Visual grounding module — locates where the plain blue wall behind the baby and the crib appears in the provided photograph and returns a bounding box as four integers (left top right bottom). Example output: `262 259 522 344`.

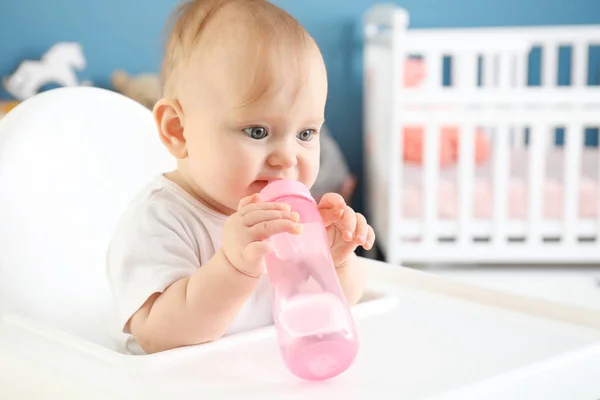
0 0 600 212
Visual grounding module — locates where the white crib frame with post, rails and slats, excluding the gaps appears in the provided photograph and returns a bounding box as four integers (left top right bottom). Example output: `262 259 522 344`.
364 4 600 264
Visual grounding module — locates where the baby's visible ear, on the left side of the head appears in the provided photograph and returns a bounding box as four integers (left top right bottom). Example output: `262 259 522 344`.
153 98 188 159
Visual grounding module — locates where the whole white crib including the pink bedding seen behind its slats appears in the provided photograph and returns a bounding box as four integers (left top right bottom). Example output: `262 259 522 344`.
364 5 600 264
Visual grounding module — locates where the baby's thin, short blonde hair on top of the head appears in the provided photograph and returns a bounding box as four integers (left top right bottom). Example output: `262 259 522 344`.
161 0 314 104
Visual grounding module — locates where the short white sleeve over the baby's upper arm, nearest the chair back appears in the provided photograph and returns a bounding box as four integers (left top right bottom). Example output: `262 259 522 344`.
107 203 200 333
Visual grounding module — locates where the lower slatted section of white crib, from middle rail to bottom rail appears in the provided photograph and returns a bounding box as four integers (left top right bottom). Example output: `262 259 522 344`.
396 110 600 262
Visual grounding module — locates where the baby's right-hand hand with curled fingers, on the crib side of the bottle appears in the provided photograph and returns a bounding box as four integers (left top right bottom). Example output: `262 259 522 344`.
319 193 375 268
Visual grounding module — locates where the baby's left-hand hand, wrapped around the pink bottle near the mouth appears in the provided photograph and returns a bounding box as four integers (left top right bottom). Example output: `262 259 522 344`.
223 194 302 278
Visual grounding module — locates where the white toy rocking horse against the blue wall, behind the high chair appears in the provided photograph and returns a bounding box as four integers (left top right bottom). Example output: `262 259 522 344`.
2 42 91 101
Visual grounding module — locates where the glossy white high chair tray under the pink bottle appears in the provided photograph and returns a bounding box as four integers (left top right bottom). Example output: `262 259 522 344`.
0 259 600 400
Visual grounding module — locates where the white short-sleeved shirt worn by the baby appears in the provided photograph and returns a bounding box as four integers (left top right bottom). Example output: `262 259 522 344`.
107 175 273 354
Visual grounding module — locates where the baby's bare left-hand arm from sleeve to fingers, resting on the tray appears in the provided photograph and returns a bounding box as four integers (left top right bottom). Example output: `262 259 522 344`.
123 196 300 353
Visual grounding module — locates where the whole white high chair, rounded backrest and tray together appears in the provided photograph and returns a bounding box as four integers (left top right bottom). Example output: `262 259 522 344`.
0 87 600 400
